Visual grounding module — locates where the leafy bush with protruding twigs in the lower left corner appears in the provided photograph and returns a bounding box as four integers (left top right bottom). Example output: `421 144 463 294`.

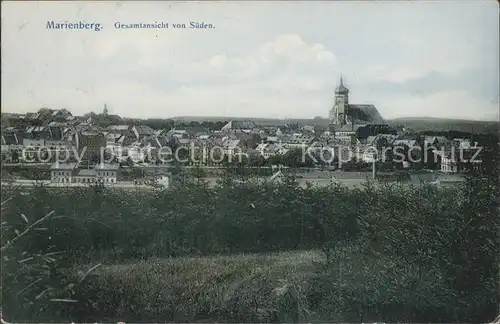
0 188 100 323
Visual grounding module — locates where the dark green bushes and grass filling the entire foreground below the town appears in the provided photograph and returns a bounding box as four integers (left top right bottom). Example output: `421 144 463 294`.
2 162 500 322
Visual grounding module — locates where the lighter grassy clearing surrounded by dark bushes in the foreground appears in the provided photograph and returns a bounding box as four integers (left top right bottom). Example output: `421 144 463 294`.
71 251 325 322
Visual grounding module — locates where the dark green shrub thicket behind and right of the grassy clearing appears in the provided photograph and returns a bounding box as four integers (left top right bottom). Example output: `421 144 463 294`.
3 168 499 322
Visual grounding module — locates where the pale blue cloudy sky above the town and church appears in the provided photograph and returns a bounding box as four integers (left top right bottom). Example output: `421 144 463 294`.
2 0 499 120
